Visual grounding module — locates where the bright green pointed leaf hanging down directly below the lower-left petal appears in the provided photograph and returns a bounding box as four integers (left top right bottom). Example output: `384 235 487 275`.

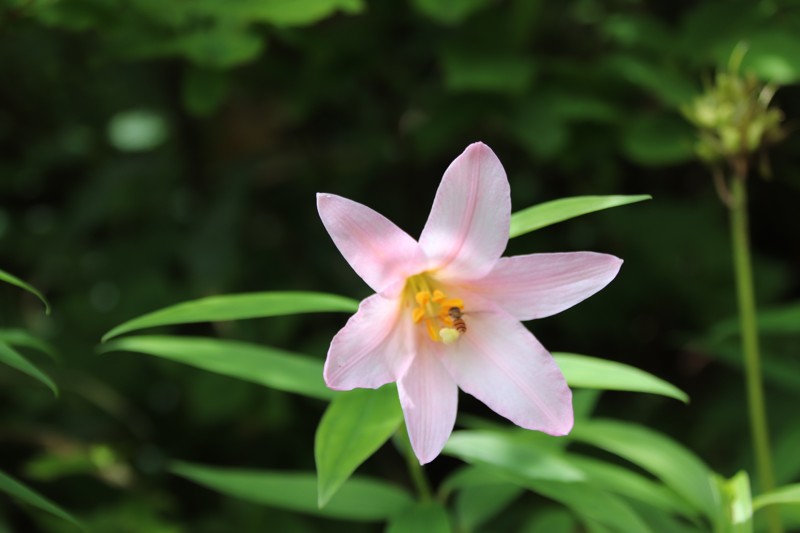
314 386 403 507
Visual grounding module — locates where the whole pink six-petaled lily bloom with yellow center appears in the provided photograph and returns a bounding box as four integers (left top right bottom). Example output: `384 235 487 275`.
317 143 622 464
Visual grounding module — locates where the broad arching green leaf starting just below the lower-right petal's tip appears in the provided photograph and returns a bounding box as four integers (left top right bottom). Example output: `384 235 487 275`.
570 419 720 518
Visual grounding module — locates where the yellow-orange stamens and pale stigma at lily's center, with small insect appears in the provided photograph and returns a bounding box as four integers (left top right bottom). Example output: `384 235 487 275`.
403 272 467 344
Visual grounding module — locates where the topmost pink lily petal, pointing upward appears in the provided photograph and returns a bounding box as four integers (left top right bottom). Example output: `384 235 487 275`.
419 143 511 279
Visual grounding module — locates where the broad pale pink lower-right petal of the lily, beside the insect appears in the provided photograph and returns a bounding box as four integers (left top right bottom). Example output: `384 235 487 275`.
442 302 573 435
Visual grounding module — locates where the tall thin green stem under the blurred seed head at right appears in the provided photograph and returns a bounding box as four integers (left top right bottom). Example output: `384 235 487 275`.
730 175 783 533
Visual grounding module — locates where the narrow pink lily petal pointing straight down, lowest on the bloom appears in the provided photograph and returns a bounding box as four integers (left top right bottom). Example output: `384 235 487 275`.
397 341 458 465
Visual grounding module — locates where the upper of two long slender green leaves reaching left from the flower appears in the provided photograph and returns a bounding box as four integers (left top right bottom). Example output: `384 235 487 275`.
103 292 358 342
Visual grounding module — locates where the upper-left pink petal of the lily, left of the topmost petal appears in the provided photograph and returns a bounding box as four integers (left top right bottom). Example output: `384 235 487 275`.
317 193 426 292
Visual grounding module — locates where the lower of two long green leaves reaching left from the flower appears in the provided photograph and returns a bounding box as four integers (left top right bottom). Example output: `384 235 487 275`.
99 335 334 400
